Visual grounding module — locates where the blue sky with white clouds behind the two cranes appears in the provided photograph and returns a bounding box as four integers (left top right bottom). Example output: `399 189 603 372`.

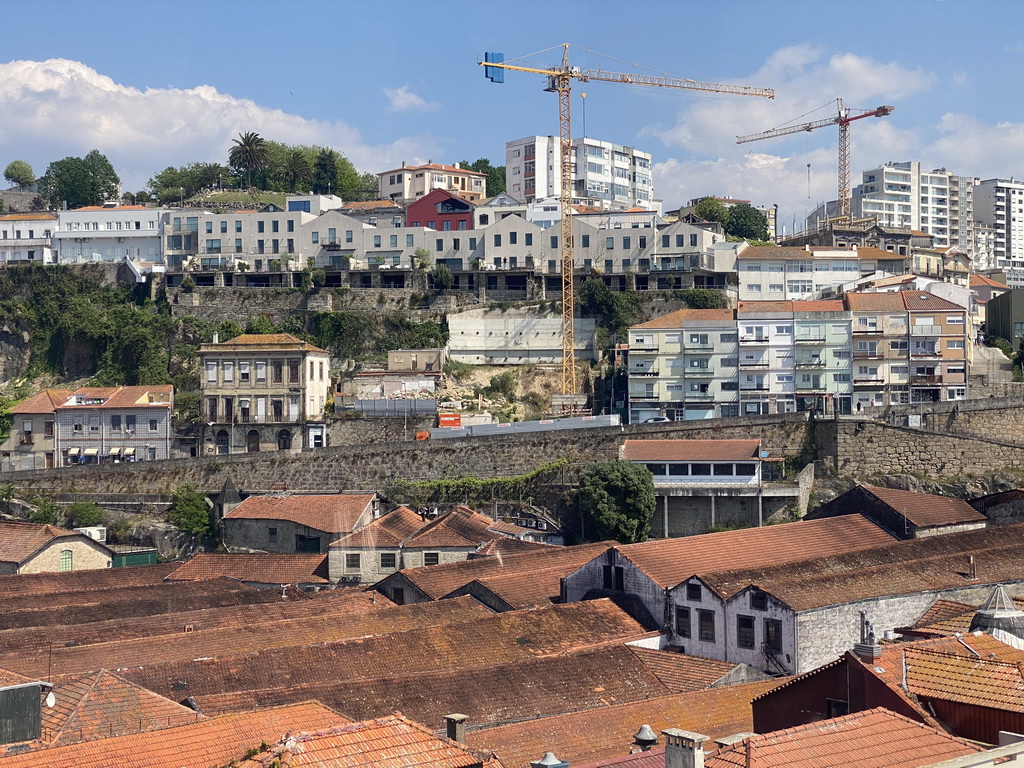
0 0 1024 230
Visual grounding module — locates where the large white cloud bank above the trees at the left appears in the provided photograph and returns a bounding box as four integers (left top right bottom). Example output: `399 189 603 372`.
0 58 438 189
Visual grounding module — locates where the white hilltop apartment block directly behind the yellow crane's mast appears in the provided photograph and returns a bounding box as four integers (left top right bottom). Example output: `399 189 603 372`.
505 136 658 210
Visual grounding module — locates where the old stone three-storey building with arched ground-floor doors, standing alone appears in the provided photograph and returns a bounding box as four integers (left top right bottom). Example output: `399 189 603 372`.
199 334 331 455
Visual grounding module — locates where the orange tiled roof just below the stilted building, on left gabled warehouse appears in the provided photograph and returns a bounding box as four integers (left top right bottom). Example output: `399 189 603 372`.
602 515 894 588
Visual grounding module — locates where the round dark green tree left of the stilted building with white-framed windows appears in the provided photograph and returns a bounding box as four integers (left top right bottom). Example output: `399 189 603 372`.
577 461 655 544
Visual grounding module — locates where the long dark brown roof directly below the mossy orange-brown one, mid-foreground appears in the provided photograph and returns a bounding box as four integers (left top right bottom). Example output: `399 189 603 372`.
198 644 675 727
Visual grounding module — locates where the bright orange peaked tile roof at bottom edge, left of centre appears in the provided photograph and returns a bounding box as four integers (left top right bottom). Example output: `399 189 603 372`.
233 713 495 768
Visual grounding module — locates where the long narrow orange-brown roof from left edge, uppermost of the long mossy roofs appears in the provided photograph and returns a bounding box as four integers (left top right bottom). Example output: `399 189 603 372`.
0 590 493 679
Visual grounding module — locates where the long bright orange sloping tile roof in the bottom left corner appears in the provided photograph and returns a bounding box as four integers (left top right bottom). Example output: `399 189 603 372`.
0 701 348 768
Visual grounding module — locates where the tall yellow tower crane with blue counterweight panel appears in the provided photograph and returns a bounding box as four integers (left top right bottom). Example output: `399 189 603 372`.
477 43 775 403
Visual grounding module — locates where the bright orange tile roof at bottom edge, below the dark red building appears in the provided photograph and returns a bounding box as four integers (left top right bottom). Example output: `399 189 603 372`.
705 707 984 768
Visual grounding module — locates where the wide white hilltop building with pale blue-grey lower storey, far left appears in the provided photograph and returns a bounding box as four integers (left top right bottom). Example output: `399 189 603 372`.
51 204 164 264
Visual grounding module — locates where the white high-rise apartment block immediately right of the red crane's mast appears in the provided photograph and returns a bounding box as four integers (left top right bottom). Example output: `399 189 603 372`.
851 162 976 253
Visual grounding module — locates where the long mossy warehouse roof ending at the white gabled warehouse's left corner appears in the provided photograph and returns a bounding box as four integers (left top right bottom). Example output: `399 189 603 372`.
117 600 642 698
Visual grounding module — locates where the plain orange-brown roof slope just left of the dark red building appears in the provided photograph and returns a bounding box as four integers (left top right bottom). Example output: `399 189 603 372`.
466 680 779 768
